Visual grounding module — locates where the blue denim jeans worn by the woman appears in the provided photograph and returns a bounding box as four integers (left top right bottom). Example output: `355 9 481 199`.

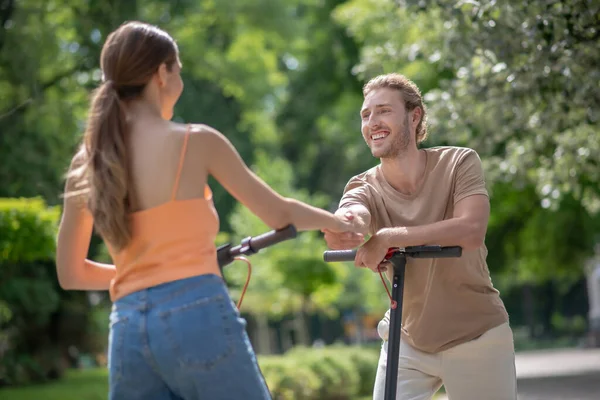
108 275 271 400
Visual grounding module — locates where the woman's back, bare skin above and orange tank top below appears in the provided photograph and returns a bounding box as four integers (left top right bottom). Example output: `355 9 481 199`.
107 119 220 301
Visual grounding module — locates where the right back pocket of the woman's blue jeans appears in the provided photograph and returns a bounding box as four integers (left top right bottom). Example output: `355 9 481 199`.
158 294 237 370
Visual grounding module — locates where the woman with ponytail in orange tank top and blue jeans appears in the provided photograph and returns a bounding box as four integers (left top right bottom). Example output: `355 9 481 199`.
56 22 352 400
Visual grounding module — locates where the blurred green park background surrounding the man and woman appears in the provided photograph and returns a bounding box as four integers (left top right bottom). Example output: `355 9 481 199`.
0 0 600 400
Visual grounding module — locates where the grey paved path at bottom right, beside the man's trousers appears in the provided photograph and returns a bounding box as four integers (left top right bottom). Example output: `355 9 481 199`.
436 349 600 400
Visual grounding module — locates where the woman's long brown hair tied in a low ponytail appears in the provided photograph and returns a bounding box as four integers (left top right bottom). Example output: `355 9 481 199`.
67 22 177 251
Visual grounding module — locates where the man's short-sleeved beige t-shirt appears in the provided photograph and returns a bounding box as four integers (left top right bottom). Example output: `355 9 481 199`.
340 147 508 353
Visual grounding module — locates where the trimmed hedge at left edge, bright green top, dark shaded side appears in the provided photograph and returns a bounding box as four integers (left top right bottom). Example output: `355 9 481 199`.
0 198 100 384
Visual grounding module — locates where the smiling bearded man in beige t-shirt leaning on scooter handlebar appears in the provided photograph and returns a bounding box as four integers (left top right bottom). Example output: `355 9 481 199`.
325 74 517 400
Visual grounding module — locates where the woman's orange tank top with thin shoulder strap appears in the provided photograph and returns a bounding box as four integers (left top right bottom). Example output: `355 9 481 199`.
107 130 221 302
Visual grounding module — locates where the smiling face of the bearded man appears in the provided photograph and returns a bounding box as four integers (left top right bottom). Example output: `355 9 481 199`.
360 88 412 158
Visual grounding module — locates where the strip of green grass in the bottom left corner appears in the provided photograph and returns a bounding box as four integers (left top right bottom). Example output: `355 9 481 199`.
0 368 108 400
